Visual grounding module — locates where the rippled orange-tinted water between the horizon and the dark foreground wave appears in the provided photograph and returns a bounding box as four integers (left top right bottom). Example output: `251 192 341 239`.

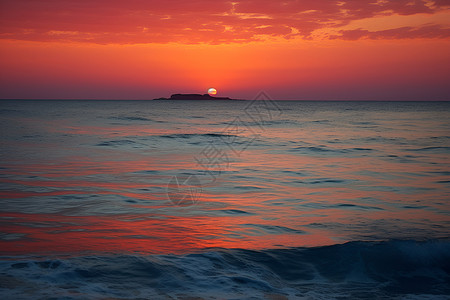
0 101 450 254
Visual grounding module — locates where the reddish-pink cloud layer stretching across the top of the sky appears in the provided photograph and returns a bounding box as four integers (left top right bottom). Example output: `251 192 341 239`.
0 0 450 44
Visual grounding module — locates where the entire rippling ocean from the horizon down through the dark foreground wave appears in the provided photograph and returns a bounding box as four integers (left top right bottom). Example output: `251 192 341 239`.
0 99 450 299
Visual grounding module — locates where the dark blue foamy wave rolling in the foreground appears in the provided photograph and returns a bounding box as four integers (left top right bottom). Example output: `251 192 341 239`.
0 240 450 299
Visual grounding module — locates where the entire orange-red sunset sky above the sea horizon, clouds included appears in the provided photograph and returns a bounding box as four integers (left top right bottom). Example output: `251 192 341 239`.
0 0 450 100
